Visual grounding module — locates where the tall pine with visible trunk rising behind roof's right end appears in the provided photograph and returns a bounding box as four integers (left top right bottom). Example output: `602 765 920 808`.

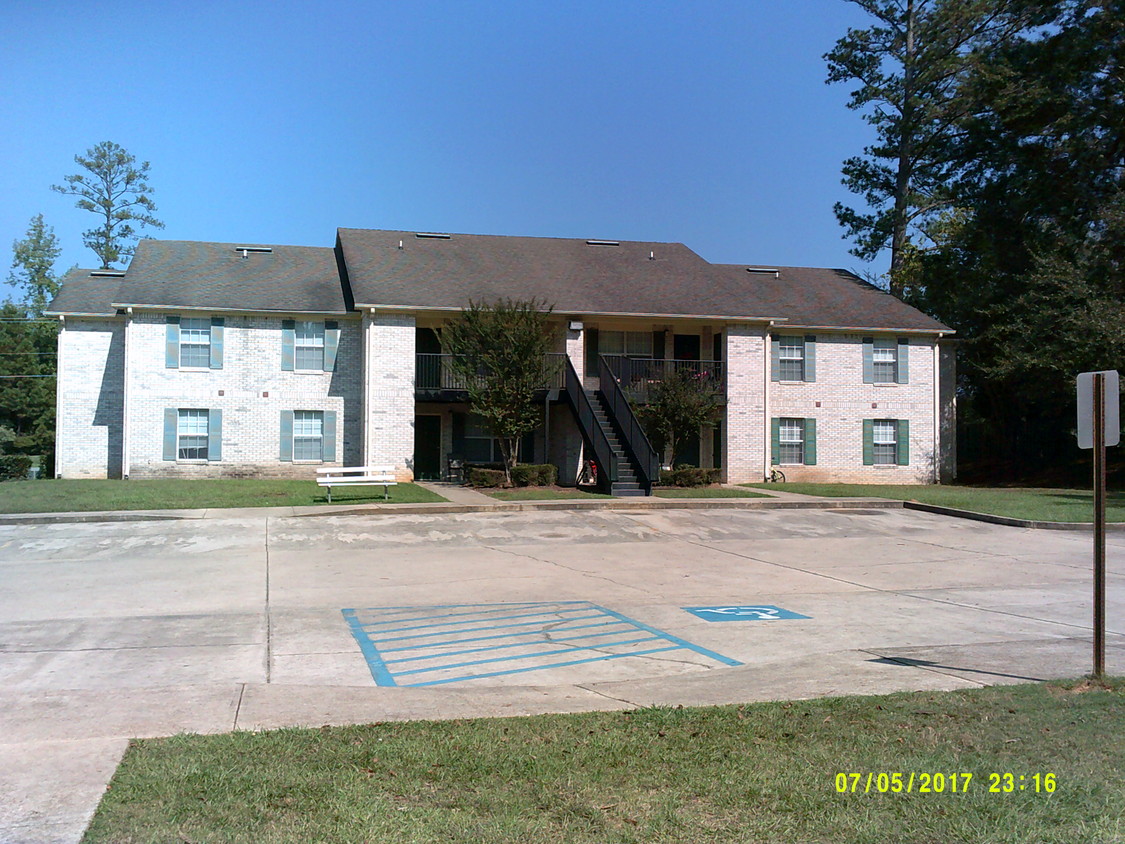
825 0 1055 296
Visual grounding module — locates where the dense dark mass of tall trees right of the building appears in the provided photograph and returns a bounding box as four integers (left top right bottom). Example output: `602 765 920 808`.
825 0 1125 481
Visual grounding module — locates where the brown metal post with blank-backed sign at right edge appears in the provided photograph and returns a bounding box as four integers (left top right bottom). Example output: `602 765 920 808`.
1078 370 1121 677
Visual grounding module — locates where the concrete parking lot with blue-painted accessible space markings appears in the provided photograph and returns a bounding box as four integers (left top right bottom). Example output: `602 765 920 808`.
0 508 1125 841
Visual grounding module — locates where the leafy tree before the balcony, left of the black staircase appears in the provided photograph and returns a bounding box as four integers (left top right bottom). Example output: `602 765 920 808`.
441 299 551 484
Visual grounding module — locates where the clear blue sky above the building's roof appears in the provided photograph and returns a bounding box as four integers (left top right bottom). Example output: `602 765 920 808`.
0 0 883 294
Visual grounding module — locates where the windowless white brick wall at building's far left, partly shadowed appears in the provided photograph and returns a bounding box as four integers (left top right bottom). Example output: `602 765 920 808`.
55 317 125 478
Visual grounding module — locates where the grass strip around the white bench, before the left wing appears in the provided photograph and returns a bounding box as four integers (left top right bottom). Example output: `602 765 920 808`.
0 478 444 513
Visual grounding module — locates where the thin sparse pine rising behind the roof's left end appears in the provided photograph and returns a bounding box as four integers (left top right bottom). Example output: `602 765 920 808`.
51 141 164 269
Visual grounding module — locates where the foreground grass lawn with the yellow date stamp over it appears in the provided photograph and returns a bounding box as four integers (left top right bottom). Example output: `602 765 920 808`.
84 680 1125 844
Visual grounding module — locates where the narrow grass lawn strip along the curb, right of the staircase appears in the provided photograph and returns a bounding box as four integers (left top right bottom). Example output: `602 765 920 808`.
744 484 1125 522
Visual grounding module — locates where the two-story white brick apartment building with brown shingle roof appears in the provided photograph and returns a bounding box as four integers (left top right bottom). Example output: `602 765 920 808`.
47 228 954 493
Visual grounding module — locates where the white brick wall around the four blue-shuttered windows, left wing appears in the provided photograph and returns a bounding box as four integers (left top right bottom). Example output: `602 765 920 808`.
127 313 362 477
